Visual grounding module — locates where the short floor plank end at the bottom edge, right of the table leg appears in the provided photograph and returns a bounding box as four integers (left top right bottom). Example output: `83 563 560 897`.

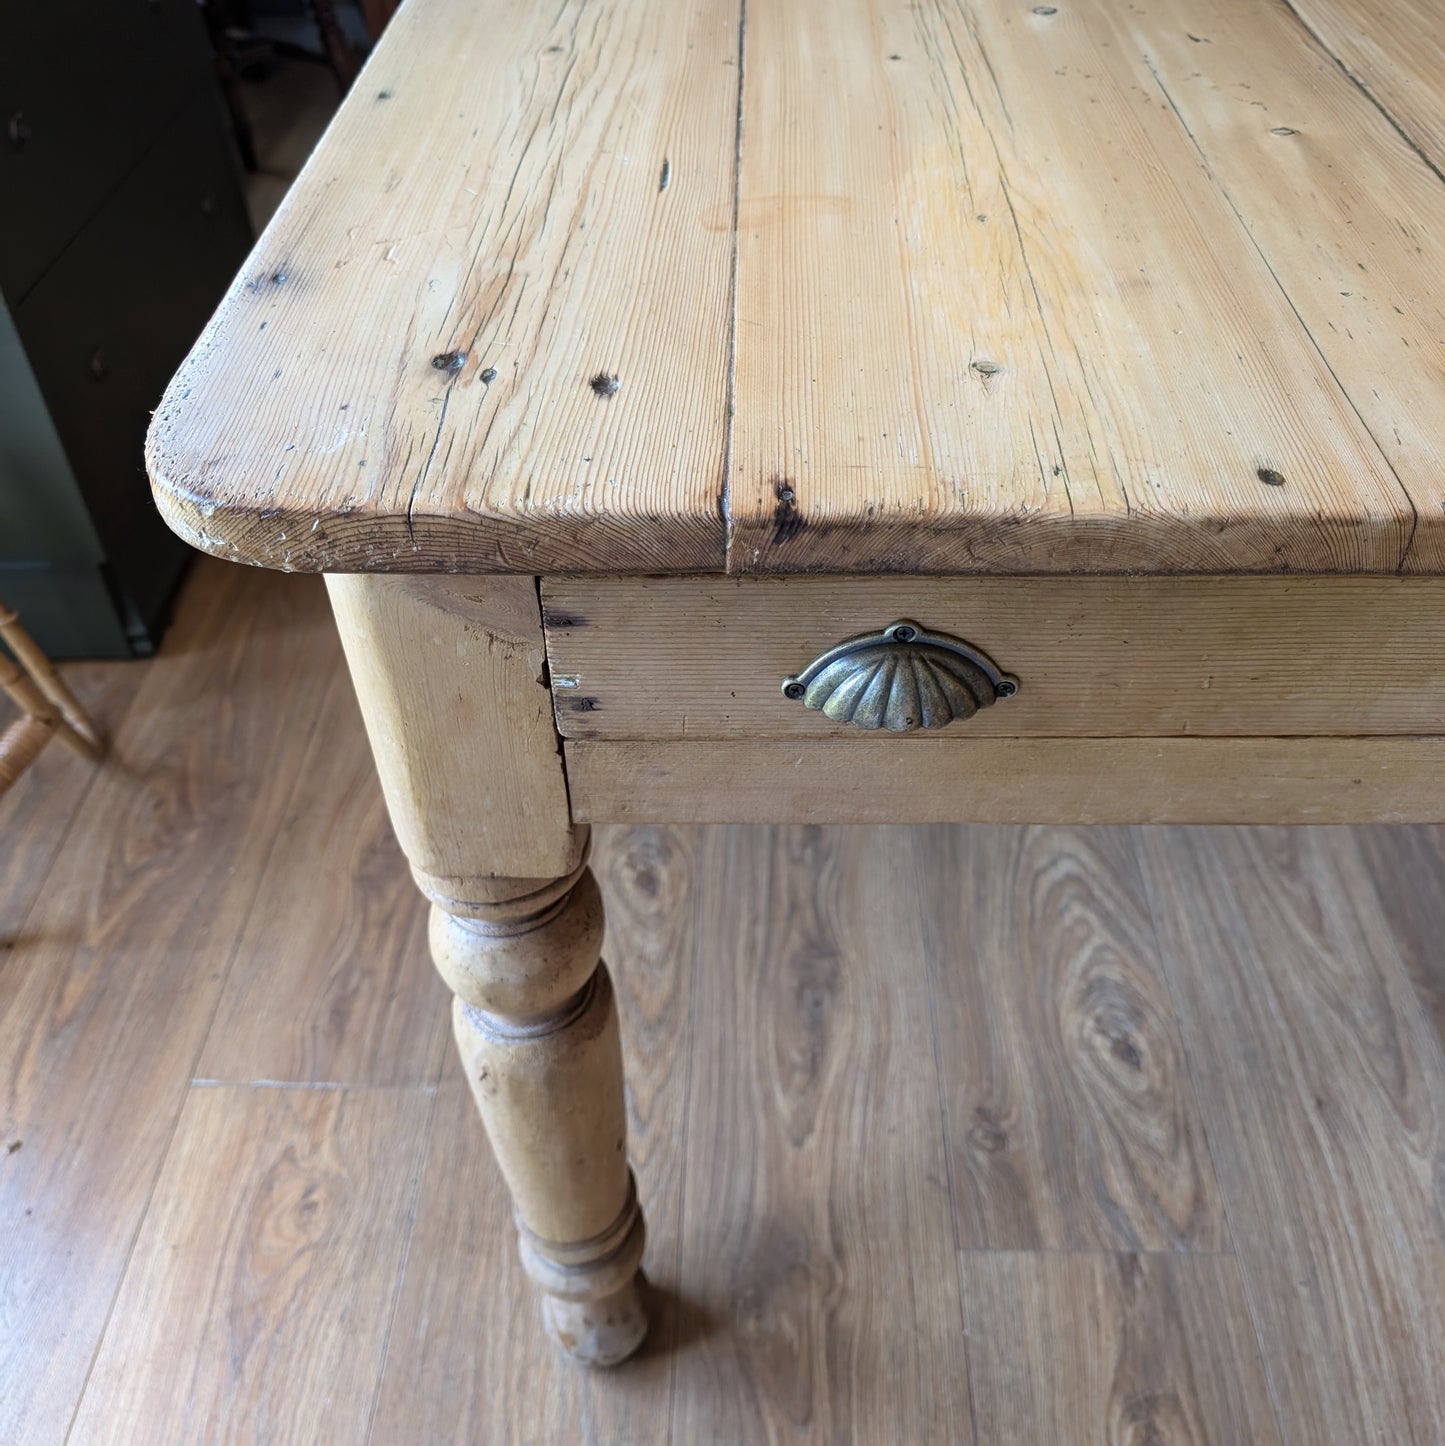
963 1255 1284 1446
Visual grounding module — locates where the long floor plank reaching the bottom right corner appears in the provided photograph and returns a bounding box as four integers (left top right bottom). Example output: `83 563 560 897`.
1141 829 1445 1446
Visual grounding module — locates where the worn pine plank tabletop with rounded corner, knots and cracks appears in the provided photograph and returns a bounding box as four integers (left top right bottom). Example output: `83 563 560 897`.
149 0 1445 573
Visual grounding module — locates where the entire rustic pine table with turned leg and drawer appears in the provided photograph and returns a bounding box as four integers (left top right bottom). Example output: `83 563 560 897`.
148 0 1445 1365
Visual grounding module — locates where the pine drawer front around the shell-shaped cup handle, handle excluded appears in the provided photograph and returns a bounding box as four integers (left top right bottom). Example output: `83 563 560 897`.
542 577 1445 746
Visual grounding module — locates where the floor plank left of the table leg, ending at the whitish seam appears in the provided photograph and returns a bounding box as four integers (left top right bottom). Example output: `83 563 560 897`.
197 665 450 1086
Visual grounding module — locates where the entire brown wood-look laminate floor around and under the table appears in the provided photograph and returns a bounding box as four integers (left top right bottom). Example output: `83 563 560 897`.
0 562 1445 1446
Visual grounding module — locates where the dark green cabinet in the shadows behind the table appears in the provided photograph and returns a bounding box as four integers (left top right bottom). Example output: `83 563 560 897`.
0 0 250 656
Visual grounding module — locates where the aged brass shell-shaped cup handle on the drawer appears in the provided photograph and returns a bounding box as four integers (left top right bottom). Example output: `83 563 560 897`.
783 622 1018 733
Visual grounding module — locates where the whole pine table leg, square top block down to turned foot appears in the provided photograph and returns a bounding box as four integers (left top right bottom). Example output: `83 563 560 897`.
327 577 647 1365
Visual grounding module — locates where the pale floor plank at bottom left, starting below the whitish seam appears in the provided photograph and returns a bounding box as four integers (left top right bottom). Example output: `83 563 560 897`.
69 1087 432 1446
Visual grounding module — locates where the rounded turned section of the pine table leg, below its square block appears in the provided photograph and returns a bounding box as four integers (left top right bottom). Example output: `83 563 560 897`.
431 868 647 1365
